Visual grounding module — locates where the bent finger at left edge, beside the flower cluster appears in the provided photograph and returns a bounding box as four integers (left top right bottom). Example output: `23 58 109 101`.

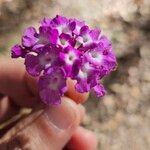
0 58 37 106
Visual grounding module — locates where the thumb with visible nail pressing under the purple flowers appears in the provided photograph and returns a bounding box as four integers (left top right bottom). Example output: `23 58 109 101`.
0 98 80 150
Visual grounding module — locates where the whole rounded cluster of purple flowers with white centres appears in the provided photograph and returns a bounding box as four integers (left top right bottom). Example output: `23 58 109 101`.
11 15 116 104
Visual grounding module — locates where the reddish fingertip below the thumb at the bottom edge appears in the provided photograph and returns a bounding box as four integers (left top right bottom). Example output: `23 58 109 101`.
64 127 97 150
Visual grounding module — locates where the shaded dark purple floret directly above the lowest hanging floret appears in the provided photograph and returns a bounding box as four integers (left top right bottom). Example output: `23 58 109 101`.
25 46 60 76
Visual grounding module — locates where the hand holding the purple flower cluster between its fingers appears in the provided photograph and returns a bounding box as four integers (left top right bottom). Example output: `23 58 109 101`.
0 58 97 150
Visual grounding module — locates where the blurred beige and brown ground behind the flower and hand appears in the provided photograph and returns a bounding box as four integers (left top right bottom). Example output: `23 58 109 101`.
0 0 150 150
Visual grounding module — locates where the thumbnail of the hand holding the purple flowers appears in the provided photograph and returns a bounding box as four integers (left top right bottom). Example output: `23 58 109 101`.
45 98 77 130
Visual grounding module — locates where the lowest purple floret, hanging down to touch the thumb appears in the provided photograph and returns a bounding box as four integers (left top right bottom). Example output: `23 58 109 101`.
38 68 67 105
